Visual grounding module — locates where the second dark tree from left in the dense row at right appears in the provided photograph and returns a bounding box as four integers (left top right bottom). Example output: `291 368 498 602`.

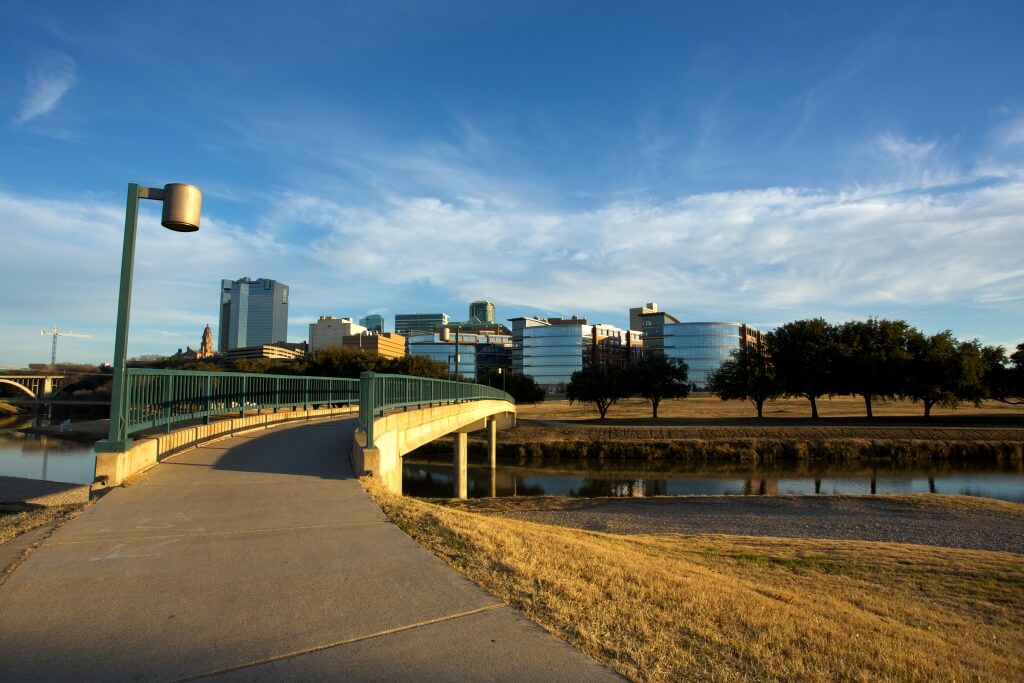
765 317 836 420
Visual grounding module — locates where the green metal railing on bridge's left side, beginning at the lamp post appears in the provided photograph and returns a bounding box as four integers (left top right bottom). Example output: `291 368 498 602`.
121 368 359 434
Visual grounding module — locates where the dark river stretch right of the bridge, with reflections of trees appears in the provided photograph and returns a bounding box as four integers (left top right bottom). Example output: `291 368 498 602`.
402 456 1024 503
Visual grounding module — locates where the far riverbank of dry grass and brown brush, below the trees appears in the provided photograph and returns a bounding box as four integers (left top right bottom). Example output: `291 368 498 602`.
420 397 1024 466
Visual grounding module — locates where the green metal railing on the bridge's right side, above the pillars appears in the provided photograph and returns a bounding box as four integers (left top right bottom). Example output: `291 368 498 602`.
359 373 515 449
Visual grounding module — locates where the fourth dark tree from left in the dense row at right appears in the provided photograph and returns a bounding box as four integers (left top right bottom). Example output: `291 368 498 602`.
906 330 986 418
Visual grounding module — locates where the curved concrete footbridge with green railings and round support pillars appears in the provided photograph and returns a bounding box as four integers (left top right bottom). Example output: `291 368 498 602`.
96 368 516 498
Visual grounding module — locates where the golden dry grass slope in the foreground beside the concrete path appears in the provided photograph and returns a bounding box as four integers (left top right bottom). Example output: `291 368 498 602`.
372 490 1024 681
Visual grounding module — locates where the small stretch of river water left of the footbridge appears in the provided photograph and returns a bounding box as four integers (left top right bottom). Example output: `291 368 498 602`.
0 419 96 483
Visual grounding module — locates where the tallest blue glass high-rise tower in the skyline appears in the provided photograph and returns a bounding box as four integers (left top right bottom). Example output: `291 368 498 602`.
217 278 288 353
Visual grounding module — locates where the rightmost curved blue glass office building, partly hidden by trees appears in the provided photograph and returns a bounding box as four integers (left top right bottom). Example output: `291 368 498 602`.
641 312 761 391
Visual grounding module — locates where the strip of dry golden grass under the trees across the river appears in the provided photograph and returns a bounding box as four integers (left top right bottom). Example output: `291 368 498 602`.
518 396 1024 424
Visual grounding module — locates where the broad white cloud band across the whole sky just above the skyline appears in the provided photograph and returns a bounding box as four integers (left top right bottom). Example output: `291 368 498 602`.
0 147 1024 362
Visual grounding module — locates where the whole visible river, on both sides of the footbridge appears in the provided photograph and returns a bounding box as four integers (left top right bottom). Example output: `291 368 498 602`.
0 418 1024 503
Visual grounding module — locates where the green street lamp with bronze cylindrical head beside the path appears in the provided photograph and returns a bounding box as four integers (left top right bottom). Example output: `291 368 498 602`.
96 182 203 453
